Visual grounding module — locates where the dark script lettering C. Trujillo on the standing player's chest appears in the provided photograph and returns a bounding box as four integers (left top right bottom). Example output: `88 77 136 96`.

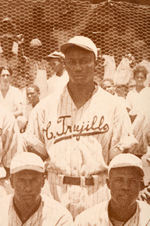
43 115 109 143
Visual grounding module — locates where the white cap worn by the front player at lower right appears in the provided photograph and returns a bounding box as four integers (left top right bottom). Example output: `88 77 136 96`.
108 153 144 176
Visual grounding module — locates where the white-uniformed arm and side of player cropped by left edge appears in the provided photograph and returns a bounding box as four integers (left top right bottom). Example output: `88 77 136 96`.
0 105 19 196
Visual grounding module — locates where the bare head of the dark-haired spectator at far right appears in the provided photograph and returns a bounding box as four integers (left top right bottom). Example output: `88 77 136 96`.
133 65 148 86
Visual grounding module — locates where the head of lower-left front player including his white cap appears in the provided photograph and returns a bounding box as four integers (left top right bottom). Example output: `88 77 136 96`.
10 152 44 206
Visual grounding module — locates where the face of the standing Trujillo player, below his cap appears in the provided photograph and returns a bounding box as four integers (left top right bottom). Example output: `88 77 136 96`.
65 47 95 85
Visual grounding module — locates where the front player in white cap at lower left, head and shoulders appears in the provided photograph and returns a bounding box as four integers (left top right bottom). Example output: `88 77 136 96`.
0 152 72 226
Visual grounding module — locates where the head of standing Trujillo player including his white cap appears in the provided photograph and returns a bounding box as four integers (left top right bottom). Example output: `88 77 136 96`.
61 36 97 85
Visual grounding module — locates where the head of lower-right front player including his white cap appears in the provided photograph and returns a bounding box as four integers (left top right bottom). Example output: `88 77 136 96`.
107 154 144 209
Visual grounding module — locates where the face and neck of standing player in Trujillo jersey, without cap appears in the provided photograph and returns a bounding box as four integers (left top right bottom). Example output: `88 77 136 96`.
65 47 96 108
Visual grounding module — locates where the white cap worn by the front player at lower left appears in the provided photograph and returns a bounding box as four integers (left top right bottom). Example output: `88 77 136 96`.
10 152 45 174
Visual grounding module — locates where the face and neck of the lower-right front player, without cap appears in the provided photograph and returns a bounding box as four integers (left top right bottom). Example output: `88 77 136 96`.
107 167 144 222
